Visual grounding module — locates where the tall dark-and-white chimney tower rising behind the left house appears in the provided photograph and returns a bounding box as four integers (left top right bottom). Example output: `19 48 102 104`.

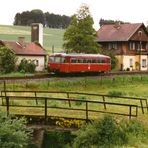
31 23 43 46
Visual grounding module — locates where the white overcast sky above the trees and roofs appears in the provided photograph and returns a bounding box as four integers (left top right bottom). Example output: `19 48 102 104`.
0 0 148 30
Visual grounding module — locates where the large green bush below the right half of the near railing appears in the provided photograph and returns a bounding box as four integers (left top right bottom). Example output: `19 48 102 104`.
74 116 127 148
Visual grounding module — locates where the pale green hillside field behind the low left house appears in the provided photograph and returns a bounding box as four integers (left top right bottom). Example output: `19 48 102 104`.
0 25 65 53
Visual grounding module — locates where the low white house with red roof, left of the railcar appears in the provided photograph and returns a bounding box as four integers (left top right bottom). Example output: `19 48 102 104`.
0 37 46 71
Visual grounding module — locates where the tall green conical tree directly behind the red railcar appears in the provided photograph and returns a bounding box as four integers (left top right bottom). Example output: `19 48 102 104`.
63 4 99 53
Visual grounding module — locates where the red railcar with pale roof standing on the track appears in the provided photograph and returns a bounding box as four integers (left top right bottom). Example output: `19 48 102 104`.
48 53 111 73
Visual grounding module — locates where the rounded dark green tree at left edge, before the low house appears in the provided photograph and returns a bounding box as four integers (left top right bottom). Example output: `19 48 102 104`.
0 46 17 73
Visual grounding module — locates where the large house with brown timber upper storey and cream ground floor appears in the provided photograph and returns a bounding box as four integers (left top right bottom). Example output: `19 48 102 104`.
97 23 148 71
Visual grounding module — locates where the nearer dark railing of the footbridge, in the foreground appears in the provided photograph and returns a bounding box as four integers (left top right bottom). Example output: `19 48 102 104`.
0 96 138 124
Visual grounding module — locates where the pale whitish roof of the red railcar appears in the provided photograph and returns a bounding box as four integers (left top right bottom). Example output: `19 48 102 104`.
50 53 110 58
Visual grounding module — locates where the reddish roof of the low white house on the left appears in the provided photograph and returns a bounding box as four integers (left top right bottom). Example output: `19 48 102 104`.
0 41 46 56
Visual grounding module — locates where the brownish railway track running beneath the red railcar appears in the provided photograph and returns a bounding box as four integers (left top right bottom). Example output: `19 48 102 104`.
0 71 148 81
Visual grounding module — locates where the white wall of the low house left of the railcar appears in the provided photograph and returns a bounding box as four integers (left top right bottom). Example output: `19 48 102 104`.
17 56 45 71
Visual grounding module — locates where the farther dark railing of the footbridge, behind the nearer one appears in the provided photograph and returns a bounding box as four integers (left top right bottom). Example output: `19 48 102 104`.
1 90 148 114
